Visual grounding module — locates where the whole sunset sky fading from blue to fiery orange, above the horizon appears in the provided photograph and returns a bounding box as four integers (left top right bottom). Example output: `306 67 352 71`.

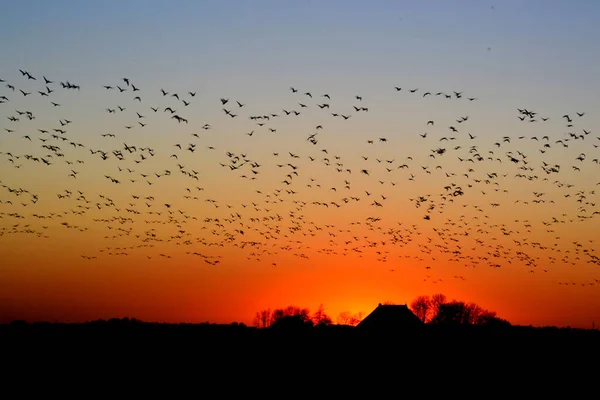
0 0 600 328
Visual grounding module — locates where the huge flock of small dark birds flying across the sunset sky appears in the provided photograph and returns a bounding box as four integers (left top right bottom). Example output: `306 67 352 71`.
0 70 600 286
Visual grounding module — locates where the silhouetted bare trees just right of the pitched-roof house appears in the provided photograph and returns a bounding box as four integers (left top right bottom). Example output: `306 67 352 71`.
409 293 510 326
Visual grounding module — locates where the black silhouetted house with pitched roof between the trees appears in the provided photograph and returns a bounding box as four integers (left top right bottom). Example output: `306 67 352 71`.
356 303 423 332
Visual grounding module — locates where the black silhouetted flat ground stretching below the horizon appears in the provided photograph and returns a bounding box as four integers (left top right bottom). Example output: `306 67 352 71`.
0 320 600 392
